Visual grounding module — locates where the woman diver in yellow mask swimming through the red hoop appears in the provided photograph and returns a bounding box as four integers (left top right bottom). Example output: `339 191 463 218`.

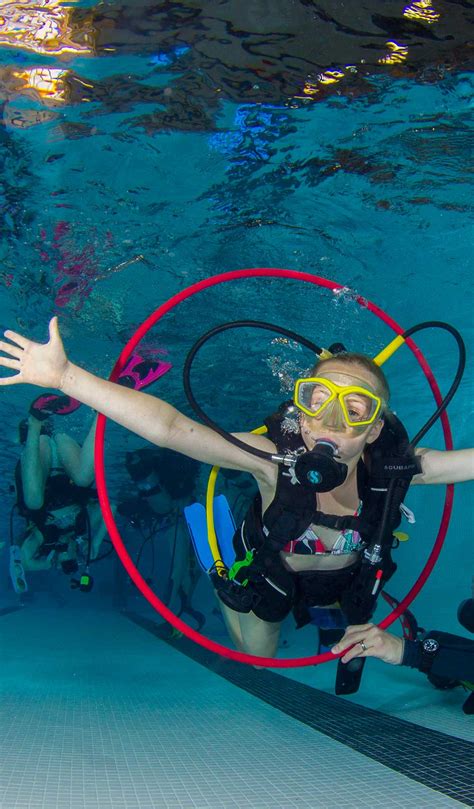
0 318 474 657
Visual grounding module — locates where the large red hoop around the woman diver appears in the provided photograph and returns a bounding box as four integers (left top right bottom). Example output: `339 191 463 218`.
94 267 454 668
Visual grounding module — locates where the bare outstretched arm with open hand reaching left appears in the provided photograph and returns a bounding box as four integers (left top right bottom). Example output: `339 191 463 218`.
0 317 276 476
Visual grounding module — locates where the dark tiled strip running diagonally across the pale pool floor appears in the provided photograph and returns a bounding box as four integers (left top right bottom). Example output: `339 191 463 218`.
125 613 474 807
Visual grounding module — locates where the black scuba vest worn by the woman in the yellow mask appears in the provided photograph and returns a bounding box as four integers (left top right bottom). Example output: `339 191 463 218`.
224 402 420 623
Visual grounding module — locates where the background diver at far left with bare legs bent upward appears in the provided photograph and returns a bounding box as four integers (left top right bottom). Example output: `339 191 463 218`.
12 402 107 580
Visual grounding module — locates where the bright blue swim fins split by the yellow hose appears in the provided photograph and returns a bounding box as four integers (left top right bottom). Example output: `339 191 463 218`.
184 494 235 573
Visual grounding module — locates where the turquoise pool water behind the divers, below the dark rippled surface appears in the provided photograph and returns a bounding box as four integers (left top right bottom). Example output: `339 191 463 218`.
0 4 474 720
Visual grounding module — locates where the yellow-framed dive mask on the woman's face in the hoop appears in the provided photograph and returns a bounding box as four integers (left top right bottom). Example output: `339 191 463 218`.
293 376 382 429
